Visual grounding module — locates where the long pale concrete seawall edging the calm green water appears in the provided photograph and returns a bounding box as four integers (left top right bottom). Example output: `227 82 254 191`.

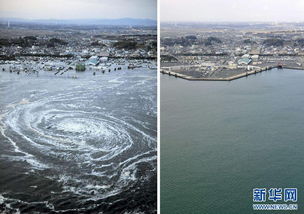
160 66 304 81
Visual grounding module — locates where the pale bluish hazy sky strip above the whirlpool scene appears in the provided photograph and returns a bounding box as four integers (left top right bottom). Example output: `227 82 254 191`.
0 0 157 19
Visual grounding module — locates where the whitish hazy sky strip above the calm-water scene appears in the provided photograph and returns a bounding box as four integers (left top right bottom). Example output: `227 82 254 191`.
160 0 304 22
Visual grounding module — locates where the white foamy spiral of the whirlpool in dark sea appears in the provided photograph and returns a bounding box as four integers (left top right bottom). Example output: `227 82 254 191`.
0 82 156 201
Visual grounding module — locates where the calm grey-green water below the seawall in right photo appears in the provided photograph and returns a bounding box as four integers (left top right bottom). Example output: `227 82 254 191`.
160 70 304 214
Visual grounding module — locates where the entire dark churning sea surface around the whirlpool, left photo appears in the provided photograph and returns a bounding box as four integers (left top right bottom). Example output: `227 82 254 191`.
0 68 157 213
